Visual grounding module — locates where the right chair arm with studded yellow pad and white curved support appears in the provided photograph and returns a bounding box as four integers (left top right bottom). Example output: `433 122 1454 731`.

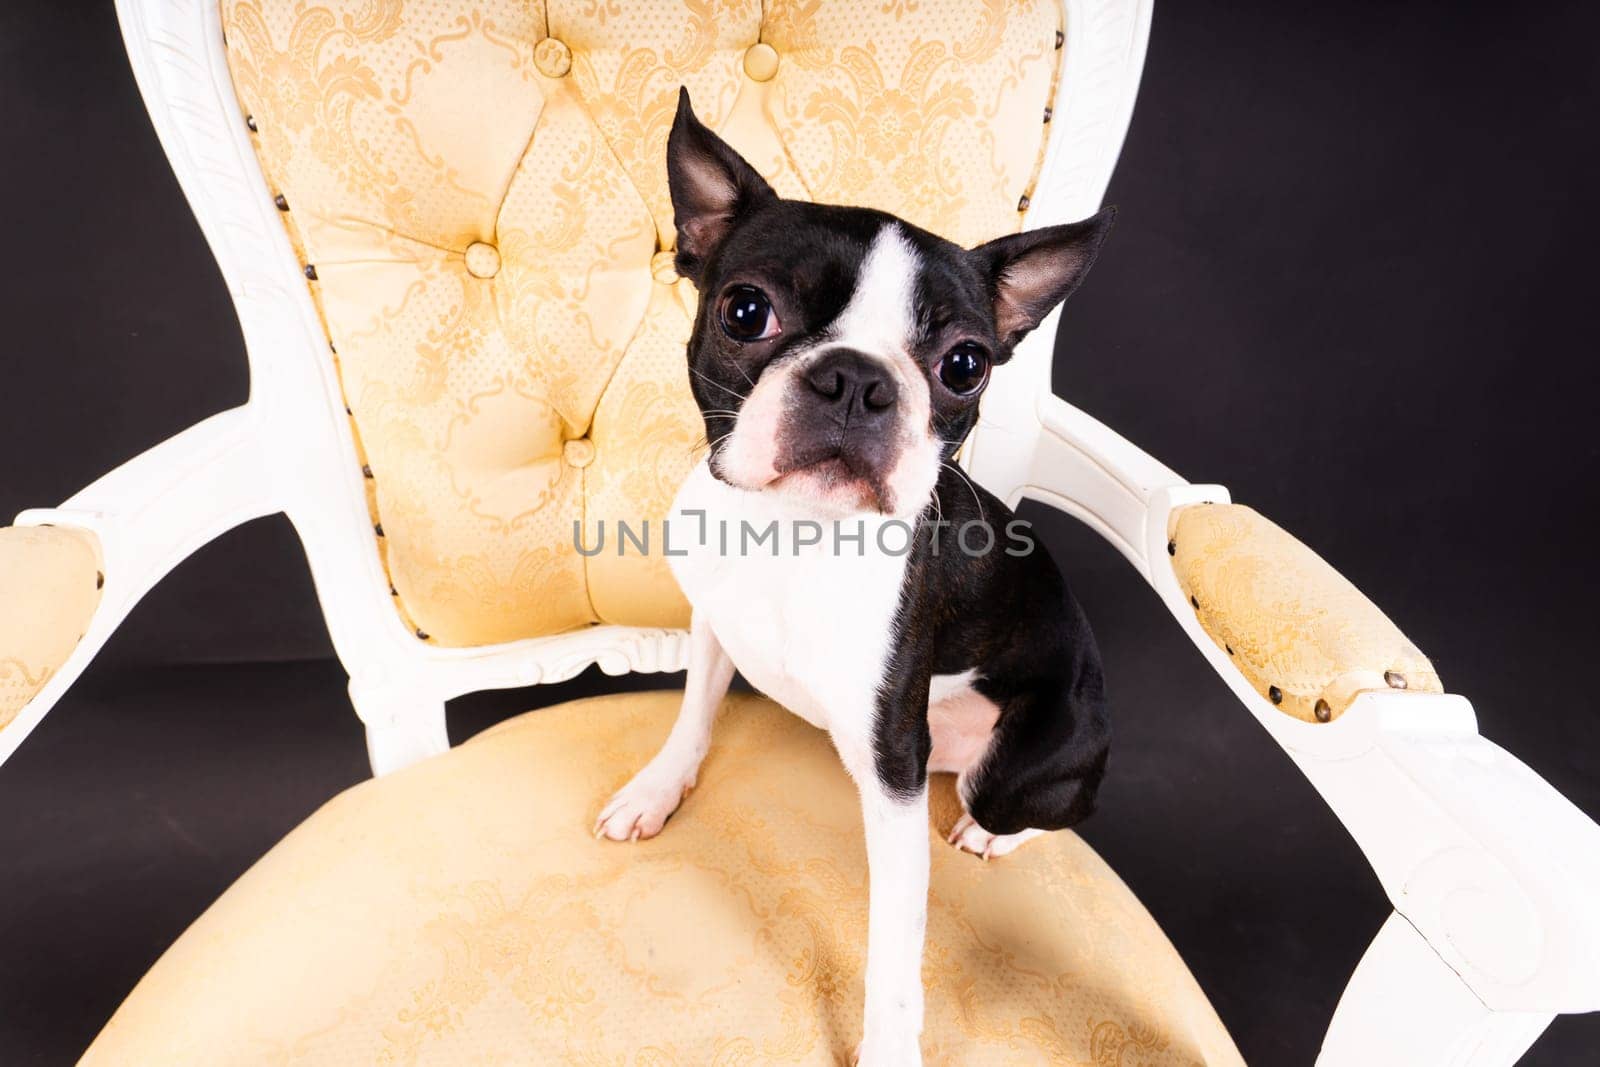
1150 505 1600 1033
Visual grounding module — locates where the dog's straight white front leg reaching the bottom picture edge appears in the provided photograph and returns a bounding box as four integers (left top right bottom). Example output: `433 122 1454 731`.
830 710 930 1067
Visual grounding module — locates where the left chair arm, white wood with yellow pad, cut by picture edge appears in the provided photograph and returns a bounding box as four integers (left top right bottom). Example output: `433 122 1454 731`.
0 405 282 763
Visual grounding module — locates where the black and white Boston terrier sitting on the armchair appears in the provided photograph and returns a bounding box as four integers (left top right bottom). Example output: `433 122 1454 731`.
595 93 1112 1067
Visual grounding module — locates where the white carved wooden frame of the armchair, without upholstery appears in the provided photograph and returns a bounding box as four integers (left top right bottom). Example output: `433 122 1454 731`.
0 0 1600 1067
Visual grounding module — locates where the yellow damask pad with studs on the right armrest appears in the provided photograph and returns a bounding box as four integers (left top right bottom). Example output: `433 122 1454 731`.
1168 504 1443 723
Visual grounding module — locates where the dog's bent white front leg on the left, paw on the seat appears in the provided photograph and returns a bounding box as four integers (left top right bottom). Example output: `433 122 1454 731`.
595 613 733 841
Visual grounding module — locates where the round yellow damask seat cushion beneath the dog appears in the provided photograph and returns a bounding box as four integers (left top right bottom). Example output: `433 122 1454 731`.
83 693 1240 1065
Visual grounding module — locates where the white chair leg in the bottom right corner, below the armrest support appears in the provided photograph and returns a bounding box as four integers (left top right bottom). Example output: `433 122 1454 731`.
1317 913 1554 1067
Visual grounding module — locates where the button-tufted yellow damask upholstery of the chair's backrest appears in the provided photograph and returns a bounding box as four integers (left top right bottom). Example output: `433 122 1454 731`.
221 0 1061 645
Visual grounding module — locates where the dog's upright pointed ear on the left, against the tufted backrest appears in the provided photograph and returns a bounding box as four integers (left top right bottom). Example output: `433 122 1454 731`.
667 90 778 285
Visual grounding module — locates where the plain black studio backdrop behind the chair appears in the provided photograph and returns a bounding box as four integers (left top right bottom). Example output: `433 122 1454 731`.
0 0 1600 1065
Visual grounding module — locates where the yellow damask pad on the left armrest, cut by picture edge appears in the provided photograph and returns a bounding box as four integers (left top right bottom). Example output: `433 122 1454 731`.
0 526 102 729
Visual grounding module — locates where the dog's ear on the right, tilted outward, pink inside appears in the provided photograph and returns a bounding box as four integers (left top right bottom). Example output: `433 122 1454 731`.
968 208 1117 347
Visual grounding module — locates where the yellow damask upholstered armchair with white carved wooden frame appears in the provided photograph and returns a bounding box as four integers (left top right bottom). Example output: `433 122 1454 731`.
0 0 1600 1064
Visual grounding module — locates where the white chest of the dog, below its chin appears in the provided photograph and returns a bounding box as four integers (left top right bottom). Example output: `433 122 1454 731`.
670 462 909 728
